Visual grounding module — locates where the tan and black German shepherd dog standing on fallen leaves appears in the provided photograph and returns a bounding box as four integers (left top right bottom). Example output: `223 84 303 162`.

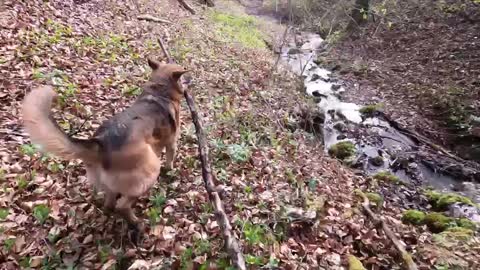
23 58 186 235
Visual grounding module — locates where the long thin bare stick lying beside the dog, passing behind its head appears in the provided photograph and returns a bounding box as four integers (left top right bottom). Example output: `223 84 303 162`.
158 39 247 270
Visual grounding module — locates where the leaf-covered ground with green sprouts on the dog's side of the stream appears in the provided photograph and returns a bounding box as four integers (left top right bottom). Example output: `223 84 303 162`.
0 0 480 269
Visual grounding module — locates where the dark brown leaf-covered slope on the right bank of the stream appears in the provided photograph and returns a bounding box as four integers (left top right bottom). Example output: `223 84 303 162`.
320 0 480 161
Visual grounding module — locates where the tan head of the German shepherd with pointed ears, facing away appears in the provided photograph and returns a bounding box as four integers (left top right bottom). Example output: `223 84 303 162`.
147 58 188 93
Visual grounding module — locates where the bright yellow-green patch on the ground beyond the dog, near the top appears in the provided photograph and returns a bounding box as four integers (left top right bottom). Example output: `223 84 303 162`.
208 11 265 48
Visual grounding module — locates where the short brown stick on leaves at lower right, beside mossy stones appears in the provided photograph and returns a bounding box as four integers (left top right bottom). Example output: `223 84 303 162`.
357 191 418 270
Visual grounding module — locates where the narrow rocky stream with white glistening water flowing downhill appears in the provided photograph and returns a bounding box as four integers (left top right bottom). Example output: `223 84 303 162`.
280 32 480 222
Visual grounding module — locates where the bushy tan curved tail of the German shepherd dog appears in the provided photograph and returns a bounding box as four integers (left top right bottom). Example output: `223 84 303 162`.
23 86 100 162
